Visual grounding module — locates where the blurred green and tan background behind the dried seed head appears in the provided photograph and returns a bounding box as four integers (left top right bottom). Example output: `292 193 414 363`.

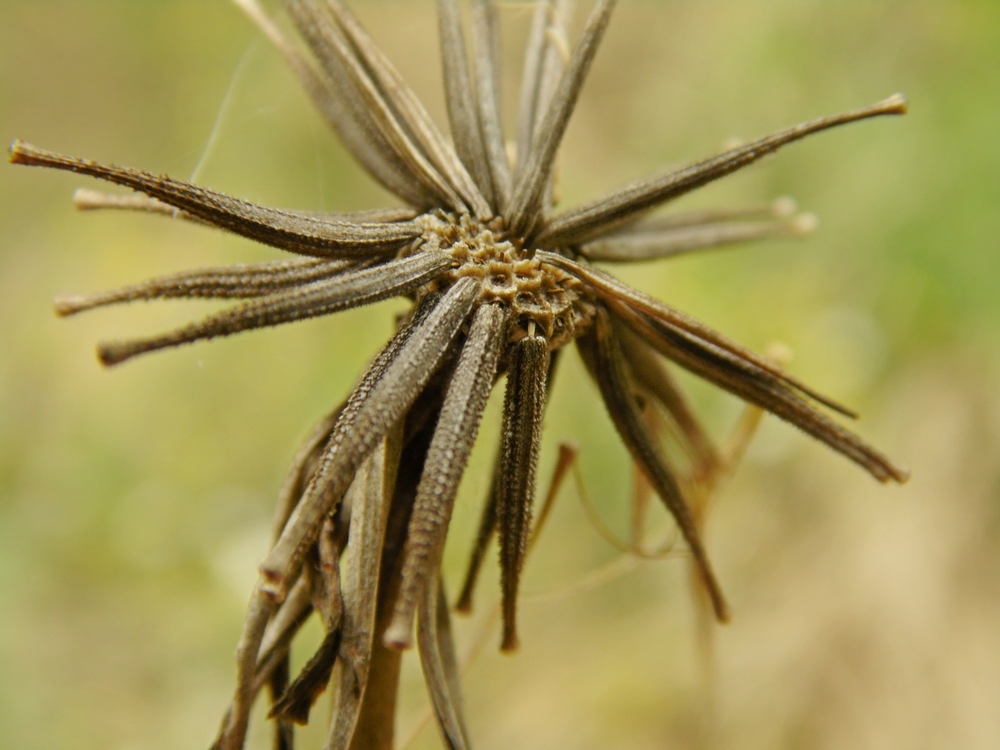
0 0 1000 750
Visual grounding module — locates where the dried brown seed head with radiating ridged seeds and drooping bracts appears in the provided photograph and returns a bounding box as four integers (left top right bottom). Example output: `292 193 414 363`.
10 0 907 750
